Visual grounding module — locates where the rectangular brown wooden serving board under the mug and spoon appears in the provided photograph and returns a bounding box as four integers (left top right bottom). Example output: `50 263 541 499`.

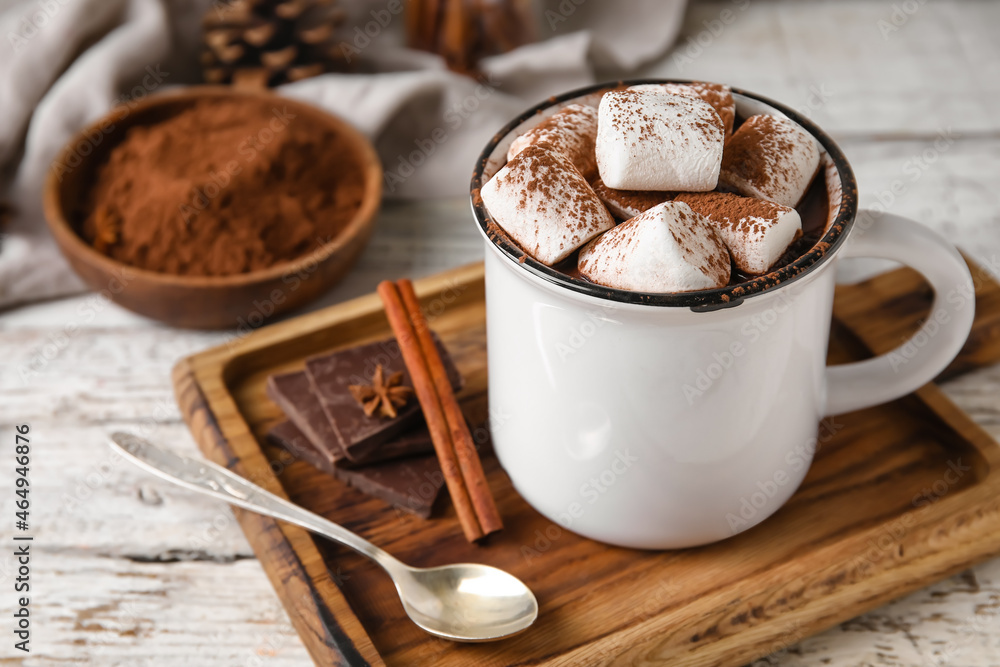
174 258 1000 667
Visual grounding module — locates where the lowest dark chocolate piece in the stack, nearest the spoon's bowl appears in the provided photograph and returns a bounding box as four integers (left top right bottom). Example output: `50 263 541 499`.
333 454 444 519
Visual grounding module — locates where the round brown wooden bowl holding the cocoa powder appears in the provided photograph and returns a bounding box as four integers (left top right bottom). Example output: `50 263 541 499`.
43 86 382 329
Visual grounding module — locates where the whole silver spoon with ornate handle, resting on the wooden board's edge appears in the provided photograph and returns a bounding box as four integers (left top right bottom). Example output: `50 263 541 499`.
110 433 538 642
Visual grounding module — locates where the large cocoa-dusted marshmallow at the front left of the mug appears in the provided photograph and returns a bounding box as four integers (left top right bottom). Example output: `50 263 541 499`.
480 143 615 266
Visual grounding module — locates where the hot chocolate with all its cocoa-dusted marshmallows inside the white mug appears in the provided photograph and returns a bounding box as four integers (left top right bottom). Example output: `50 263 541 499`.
481 79 829 293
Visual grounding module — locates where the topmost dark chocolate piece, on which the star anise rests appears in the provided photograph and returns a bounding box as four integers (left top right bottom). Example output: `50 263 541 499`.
306 336 462 463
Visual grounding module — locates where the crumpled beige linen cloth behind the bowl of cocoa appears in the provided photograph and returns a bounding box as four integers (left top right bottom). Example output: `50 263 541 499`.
0 0 684 309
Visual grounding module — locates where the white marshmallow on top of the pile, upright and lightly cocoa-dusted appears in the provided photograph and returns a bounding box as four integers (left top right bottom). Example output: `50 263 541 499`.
597 90 724 192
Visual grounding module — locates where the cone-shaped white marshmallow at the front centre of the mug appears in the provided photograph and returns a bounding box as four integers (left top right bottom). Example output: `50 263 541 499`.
577 201 730 292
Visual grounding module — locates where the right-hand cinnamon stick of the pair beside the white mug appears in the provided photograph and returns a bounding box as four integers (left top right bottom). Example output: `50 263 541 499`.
396 280 503 535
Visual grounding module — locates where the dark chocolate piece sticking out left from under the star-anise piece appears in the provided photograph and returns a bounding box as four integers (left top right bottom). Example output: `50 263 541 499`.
266 371 347 469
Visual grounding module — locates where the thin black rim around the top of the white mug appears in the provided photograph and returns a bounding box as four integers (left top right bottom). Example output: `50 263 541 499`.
470 79 858 311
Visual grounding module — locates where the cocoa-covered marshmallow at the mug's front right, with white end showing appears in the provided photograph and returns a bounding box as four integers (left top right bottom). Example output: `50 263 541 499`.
675 192 802 275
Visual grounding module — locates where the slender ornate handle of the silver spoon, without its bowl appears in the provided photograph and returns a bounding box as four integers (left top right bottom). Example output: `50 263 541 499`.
110 432 401 570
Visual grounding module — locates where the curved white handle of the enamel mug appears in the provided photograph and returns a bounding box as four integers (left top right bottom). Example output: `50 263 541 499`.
826 212 975 416
